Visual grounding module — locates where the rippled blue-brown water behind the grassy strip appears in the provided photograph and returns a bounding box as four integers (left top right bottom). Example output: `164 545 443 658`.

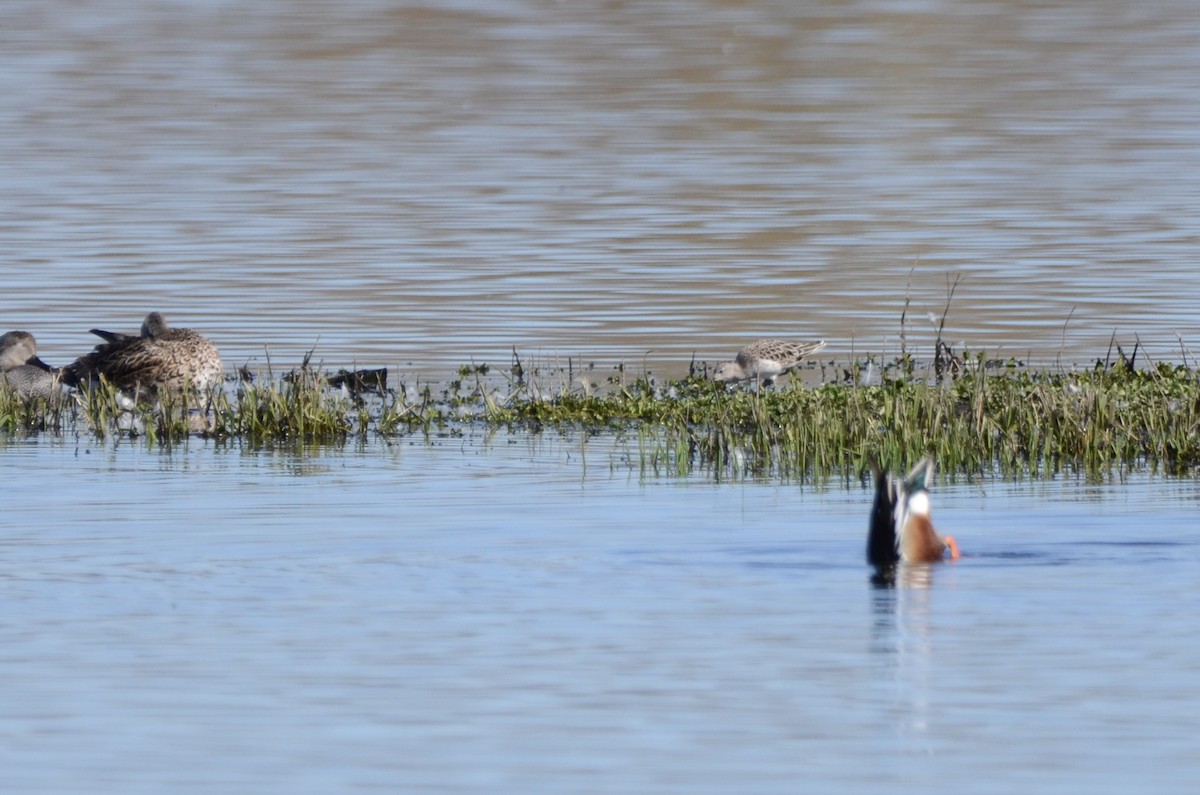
0 0 1200 378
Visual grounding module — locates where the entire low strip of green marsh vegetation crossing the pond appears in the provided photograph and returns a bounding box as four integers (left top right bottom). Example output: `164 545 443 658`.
0 348 1200 479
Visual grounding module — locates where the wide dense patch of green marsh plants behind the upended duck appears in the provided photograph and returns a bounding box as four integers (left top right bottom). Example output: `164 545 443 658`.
472 357 1200 478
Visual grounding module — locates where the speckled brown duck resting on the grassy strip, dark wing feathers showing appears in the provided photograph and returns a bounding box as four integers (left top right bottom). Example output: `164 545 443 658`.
64 312 222 394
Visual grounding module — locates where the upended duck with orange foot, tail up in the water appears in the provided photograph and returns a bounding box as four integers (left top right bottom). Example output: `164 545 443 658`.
866 456 959 572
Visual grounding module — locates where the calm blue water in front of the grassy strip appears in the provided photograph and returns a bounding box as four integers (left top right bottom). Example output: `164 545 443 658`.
0 435 1200 793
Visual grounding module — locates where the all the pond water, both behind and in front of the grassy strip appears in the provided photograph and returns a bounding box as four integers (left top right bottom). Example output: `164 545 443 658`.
0 0 1200 794
